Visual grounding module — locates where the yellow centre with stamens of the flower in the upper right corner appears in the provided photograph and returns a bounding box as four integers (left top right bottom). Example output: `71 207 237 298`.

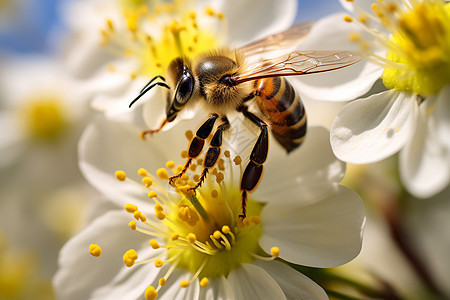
347 0 450 96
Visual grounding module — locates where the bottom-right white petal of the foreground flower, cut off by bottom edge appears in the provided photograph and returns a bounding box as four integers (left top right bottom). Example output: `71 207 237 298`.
255 261 328 300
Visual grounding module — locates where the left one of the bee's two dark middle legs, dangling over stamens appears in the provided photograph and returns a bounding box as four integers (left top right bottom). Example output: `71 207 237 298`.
169 114 219 185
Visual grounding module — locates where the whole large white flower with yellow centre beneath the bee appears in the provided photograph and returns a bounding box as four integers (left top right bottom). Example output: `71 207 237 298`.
54 114 364 299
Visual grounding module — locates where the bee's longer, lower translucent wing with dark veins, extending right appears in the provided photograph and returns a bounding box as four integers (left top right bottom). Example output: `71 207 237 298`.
232 50 361 84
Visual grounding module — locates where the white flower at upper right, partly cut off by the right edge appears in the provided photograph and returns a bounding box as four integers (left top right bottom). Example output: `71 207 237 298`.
298 0 450 198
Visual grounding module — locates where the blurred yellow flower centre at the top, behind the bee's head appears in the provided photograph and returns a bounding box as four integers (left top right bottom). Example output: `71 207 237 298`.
101 0 226 78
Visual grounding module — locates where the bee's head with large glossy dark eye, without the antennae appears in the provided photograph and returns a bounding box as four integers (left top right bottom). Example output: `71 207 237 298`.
166 57 195 122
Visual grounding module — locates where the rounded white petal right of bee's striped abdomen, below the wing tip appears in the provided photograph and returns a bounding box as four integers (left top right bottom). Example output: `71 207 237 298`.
331 91 417 164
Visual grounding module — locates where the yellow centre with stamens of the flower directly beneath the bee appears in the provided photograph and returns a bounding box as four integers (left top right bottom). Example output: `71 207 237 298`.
89 145 279 299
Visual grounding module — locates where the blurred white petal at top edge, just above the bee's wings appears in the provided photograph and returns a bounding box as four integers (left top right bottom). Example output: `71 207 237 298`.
215 0 297 46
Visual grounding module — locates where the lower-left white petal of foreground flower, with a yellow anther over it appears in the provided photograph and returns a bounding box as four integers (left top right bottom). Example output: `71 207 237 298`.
53 211 146 300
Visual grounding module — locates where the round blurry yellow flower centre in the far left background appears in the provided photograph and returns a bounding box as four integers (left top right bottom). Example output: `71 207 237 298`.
19 95 69 141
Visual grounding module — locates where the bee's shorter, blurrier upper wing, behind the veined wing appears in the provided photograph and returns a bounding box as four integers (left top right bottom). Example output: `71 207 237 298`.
239 22 313 57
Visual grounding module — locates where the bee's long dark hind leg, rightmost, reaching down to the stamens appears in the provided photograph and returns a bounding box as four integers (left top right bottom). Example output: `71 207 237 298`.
239 107 269 219
